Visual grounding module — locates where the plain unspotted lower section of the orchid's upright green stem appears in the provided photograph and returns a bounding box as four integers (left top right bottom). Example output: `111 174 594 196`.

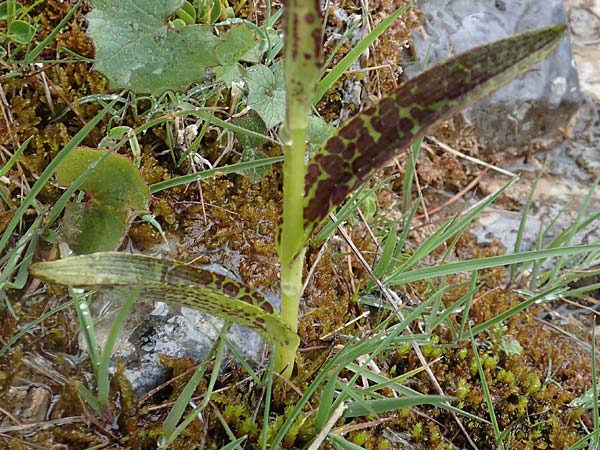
275 128 306 378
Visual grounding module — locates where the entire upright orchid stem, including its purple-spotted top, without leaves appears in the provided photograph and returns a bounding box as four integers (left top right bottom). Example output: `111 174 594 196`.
275 0 322 378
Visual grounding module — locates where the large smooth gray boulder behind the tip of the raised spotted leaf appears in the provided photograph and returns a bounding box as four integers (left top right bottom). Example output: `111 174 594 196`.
406 0 581 151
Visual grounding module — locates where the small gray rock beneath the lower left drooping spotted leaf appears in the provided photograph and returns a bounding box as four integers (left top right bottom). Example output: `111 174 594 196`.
80 264 280 396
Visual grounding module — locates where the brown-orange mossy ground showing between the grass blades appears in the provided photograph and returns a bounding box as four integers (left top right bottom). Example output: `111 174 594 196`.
0 0 593 449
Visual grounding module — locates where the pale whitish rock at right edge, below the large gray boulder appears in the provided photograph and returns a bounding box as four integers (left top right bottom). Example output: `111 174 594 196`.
471 96 600 252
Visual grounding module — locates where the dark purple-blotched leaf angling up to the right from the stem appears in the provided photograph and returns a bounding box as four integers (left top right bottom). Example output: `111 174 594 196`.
304 25 565 238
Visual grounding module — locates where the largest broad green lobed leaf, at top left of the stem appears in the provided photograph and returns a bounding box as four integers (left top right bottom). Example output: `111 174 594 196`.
87 0 218 95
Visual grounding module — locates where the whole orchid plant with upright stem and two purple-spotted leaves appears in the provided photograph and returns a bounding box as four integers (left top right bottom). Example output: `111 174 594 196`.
31 0 565 378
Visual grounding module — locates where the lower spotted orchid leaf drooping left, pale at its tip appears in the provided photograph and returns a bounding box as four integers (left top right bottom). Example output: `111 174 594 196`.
30 252 300 352
